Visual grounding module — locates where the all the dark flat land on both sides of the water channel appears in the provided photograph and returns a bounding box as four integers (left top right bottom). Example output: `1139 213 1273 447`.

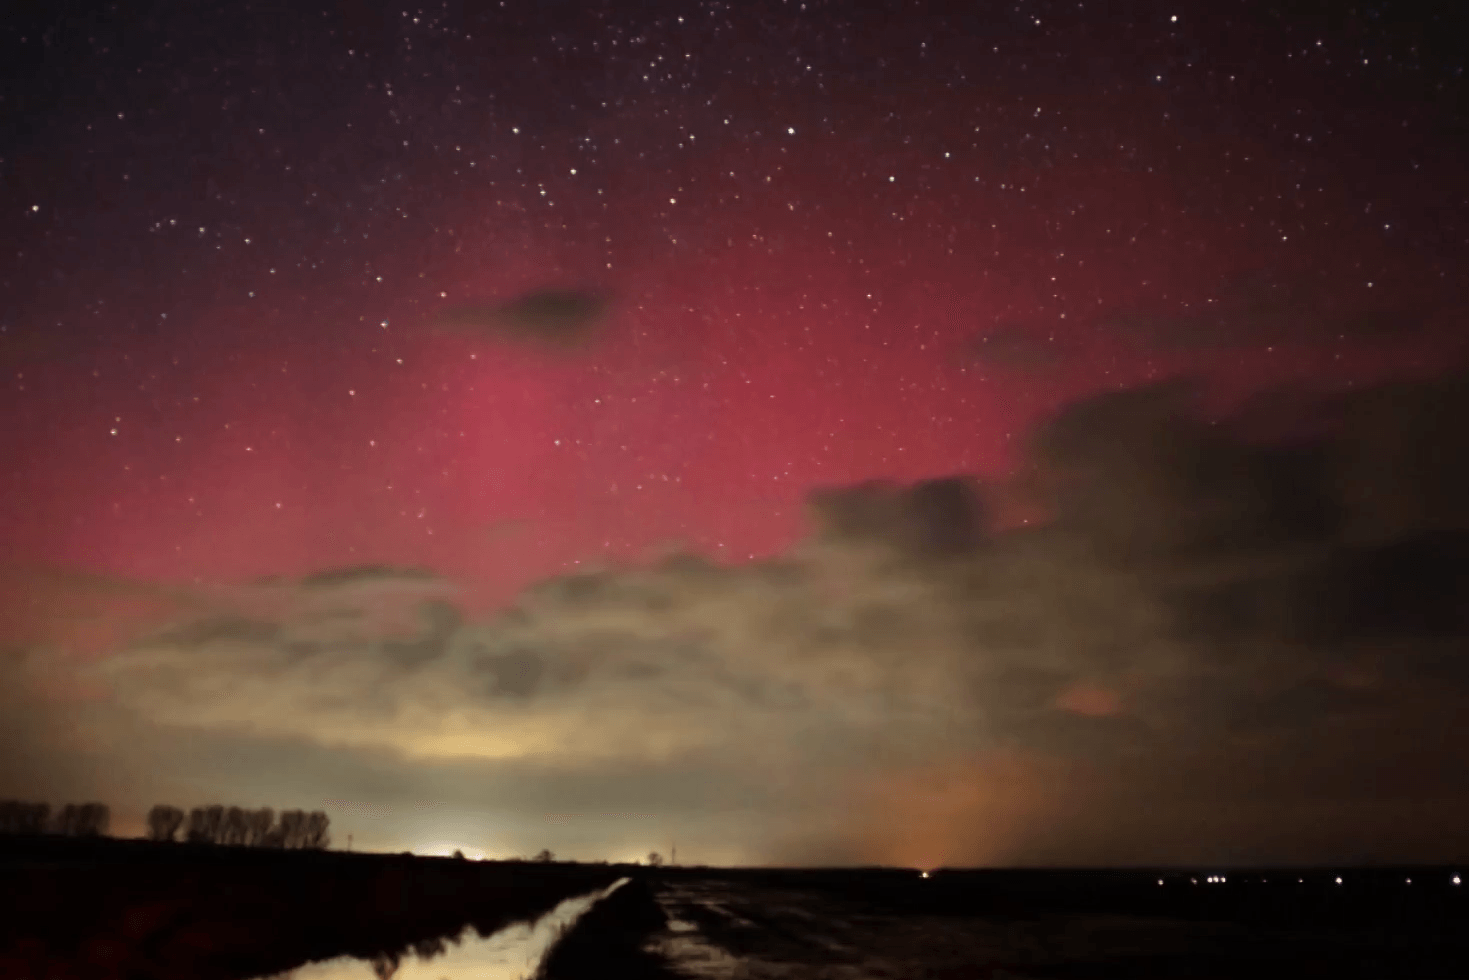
0 837 1469 980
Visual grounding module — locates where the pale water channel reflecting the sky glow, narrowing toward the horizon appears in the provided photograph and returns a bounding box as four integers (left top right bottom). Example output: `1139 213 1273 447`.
269 879 627 980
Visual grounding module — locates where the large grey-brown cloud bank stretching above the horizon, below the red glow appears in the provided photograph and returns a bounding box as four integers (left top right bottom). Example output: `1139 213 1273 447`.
17 371 1469 862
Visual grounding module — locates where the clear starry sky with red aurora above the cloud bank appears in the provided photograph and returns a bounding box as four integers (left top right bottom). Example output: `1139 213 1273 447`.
0 3 1466 605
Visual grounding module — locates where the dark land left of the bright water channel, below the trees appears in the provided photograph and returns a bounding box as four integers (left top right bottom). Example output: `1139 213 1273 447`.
0 837 624 980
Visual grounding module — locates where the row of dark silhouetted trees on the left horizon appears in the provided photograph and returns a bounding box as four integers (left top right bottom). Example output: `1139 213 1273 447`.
0 799 332 851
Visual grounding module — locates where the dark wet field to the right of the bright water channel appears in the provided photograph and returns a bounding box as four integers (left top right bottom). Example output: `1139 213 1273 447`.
544 868 1469 980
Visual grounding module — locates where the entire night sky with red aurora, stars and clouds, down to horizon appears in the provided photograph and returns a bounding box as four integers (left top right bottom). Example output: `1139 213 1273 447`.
0 0 1469 864
